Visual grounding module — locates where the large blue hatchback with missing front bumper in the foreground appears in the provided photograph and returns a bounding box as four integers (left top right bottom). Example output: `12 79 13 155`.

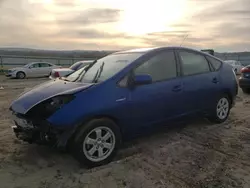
10 47 238 167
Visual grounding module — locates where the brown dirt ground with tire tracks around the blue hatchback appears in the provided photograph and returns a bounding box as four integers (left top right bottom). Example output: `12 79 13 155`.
0 76 250 188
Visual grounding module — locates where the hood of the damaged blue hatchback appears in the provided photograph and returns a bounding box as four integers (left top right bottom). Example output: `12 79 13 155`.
11 79 93 114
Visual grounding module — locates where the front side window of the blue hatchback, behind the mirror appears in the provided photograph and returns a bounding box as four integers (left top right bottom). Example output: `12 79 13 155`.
134 51 177 82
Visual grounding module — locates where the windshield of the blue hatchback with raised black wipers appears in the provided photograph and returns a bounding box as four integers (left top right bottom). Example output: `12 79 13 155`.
66 52 144 83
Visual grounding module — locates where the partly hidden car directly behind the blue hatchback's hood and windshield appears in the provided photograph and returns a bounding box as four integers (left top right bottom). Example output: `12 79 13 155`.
50 60 93 79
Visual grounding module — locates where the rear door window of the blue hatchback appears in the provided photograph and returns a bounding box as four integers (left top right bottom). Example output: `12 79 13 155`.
179 51 210 76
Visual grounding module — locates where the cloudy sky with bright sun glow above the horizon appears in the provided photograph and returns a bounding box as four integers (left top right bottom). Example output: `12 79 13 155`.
0 0 250 52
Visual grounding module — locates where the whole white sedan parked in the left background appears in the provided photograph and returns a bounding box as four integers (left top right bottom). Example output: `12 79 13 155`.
6 62 61 79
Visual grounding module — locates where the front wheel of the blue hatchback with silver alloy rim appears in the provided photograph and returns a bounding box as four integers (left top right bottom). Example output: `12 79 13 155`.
72 118 121 168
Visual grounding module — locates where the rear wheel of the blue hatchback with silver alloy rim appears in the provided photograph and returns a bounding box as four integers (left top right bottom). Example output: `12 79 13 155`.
208 95 231 123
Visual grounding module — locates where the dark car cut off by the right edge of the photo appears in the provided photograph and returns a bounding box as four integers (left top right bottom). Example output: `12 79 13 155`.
239 65 250 94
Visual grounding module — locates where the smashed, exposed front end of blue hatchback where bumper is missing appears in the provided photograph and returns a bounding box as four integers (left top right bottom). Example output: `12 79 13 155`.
12 113 74 150
